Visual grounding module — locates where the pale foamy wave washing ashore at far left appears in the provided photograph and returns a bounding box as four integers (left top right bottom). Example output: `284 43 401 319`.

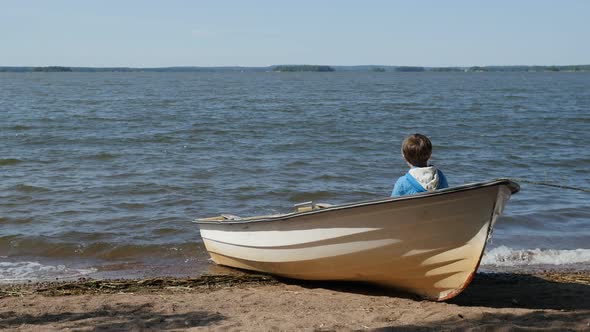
0 262 97 283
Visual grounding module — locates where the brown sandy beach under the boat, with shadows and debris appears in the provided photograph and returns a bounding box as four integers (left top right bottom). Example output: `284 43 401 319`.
0 271 590 331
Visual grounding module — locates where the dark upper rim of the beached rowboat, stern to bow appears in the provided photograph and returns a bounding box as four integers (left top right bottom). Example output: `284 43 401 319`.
193 179 520 225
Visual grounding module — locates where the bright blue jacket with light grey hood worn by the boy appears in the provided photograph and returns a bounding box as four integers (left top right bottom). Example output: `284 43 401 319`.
391 166 449 197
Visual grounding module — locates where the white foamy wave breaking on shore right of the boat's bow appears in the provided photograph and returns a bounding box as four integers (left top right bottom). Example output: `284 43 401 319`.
481 246 590 266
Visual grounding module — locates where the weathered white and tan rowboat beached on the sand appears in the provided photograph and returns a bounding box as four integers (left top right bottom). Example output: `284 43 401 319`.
195 179 520 301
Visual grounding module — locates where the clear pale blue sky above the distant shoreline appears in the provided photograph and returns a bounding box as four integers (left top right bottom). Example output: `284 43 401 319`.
0 0 590 67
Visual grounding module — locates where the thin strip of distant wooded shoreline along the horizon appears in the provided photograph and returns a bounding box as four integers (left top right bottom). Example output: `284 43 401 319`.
0 65 590 73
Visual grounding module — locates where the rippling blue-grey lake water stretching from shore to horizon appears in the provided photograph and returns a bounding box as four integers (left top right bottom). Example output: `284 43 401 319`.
0 72 590 281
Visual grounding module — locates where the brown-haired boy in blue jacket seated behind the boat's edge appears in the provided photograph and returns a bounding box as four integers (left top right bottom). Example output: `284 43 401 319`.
391 134 449 197
